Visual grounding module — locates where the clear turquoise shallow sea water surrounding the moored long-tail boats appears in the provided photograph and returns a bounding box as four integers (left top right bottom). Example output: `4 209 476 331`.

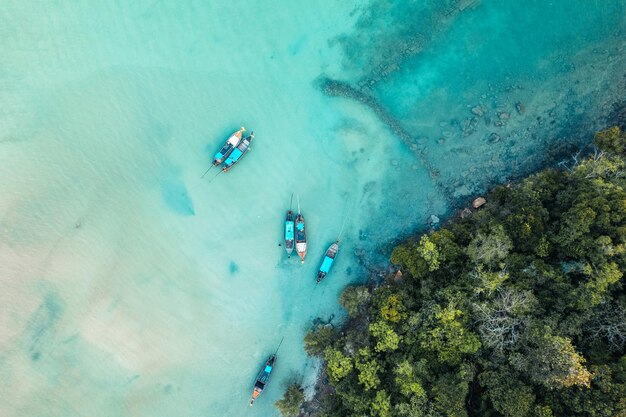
0 0 626 417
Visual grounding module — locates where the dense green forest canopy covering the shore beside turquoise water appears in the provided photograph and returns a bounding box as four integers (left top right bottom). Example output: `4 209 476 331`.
282 128 626 417
